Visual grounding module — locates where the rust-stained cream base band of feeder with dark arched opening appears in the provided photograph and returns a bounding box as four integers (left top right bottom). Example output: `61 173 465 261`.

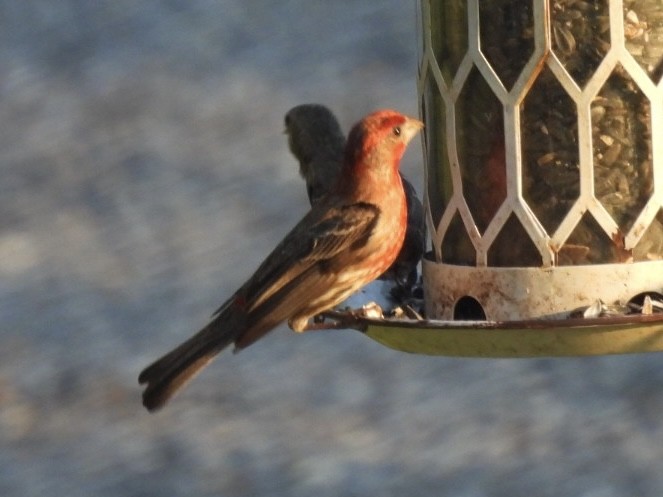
423 259 663 321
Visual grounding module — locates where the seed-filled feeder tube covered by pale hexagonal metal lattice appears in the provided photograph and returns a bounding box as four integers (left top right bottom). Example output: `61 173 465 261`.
418 0 663 268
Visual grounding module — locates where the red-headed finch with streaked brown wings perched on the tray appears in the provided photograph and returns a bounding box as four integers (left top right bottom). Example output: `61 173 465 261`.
138 110 423 411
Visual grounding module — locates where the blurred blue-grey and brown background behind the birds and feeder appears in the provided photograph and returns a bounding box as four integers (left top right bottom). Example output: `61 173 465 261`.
0 0 663 497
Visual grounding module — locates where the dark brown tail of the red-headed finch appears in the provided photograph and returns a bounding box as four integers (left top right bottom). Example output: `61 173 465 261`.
138 313 242 411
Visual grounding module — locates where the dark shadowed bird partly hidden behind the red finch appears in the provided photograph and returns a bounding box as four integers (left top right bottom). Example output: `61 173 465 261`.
285 104 426 297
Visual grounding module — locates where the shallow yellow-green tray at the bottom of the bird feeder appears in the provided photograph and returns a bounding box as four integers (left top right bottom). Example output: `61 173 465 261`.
353 314 663 358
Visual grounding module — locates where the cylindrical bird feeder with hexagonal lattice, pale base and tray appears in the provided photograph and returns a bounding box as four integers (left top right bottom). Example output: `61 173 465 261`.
360 0 663 356
